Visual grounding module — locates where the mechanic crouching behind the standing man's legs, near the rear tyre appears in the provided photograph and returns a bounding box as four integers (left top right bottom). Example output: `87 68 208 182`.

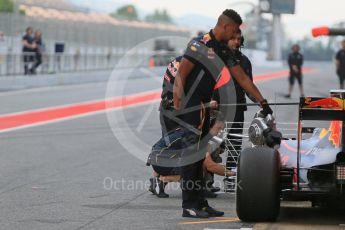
148 112 235 198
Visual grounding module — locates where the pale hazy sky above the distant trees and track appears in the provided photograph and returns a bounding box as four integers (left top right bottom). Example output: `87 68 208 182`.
73 0 345 38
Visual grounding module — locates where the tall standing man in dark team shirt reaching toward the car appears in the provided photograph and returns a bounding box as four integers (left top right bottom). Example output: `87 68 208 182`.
173 9 272 218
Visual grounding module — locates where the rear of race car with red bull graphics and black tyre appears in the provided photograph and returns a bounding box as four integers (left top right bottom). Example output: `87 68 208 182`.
236 90 345 221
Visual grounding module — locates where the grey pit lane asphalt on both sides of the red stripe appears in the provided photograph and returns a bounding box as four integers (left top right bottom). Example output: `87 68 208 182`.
0 63 345 229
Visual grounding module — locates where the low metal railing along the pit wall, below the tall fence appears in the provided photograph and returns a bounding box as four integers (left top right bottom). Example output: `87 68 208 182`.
0 52 177 76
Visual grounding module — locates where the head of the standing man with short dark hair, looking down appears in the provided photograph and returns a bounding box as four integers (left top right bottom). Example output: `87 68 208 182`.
214 9 242 42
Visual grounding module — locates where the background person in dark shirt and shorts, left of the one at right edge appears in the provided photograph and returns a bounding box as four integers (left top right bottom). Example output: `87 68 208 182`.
285 44 304 98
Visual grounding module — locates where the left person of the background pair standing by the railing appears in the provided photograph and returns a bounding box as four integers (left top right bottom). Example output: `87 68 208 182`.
22 27 36 75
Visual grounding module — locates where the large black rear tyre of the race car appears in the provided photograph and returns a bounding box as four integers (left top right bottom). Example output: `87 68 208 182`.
236 147 280 222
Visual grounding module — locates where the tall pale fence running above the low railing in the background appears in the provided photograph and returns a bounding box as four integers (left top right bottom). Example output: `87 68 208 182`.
0 13 190 54
